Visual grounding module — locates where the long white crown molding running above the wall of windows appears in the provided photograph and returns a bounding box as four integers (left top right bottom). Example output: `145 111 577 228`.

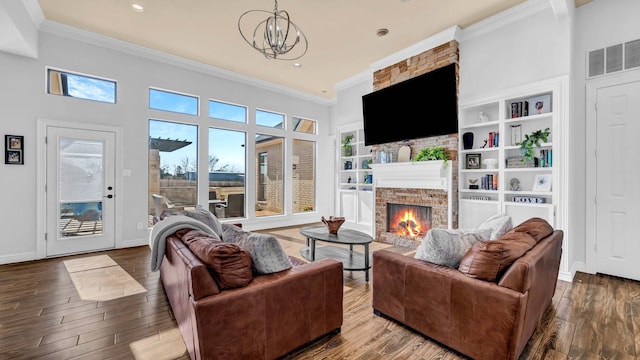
40 19 336 106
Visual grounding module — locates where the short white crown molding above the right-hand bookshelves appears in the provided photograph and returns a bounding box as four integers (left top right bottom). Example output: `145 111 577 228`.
459 0 556 42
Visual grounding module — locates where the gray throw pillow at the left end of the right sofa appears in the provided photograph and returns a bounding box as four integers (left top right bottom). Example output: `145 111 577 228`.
414 229 491 269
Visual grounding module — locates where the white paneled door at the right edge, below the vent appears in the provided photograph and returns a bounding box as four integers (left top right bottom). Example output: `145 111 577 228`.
596 82 640 280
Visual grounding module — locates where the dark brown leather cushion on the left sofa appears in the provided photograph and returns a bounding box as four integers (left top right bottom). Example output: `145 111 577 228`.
182 230 253 290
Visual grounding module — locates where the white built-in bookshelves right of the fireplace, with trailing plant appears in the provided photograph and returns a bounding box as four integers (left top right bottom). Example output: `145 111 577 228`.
458 81 563 228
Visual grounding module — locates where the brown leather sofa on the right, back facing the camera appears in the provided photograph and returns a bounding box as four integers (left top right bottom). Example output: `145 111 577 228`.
372 218 563 360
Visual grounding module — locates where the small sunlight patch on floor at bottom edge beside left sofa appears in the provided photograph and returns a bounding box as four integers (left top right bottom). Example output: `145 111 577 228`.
129 328 187 360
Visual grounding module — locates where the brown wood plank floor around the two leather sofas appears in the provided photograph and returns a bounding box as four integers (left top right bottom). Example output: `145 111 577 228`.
0 228 640 360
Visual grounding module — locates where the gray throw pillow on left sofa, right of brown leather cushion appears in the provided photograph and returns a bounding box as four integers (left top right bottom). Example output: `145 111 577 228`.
222 224 292 275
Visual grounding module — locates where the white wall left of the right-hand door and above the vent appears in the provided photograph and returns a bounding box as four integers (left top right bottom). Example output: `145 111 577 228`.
570 0 640 270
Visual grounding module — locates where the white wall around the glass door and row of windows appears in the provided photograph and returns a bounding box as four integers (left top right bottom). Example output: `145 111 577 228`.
0 28 333 263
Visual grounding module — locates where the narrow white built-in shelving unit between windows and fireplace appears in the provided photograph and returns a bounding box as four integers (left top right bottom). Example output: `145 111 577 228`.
336 124 375 234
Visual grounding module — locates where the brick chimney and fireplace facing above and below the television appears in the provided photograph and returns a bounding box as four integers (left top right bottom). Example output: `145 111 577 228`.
372 40 460 247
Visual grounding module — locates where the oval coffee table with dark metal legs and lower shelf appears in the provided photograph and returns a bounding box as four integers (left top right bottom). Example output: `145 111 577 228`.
300 225 373 282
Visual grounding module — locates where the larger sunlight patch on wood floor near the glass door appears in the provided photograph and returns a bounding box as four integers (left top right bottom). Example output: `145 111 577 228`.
63 255 147 301
